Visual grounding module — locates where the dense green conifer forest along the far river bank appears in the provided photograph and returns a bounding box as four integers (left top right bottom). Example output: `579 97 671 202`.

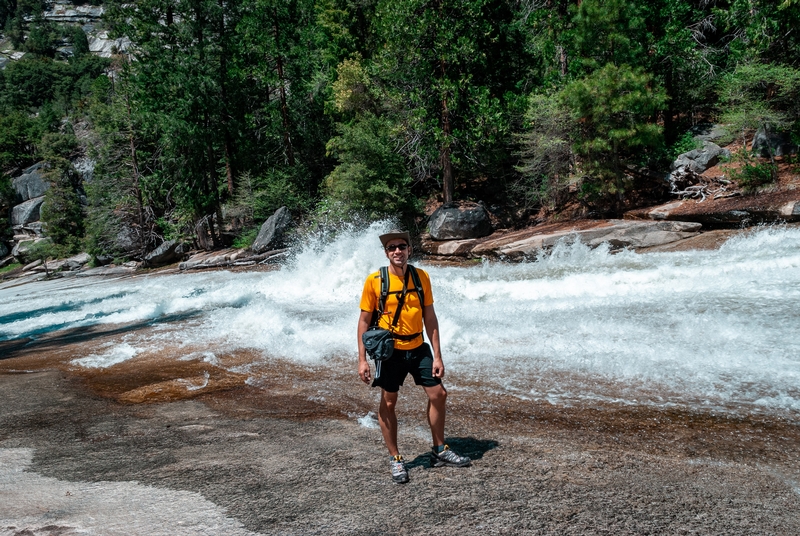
0 0 800 258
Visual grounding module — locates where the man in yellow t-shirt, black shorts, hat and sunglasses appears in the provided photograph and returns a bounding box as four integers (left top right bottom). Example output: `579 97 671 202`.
358 231 470 484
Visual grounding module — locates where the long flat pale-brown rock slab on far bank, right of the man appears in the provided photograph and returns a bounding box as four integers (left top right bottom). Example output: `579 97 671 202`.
422 220 702 258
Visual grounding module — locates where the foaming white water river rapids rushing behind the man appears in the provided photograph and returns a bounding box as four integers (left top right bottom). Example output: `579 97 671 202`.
0 224 800 417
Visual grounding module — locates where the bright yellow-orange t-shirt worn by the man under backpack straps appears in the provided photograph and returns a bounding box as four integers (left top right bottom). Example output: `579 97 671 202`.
360 268 433 350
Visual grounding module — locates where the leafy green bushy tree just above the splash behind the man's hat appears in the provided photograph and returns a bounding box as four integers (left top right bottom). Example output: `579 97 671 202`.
324 114 419 219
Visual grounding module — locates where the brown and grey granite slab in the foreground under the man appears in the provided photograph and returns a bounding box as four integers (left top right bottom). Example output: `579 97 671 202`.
0 331 800 535
